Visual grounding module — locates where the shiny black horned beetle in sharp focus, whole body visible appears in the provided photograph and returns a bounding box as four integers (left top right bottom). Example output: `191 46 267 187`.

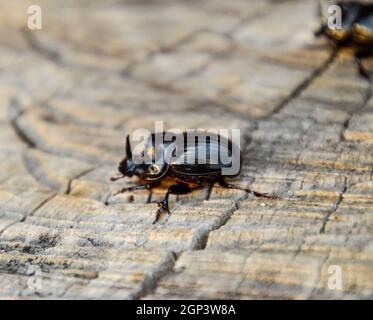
110 132 277 224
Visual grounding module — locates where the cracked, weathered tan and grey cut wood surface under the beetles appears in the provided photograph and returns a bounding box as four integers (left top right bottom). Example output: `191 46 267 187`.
0 0 373 299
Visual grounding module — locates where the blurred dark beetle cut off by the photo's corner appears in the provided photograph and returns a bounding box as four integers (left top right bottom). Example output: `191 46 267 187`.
315 1 373 82
